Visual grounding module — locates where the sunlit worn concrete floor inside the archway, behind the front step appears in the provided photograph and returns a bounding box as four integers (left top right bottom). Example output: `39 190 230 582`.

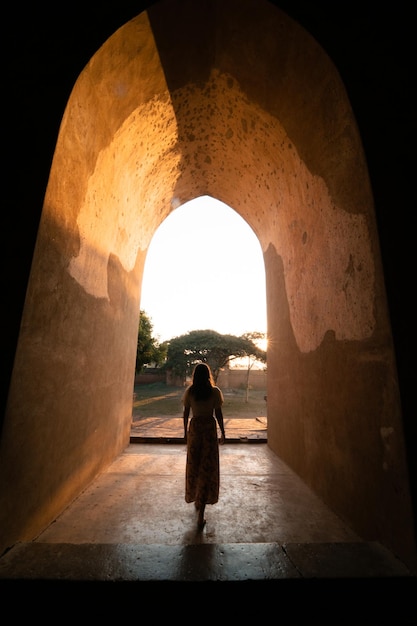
29 444 360 546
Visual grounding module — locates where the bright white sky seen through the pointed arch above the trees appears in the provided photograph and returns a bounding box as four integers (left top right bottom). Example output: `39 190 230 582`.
140 196 266 342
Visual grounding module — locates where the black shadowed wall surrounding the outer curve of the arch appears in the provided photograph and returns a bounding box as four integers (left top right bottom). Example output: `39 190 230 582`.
0 0 417 516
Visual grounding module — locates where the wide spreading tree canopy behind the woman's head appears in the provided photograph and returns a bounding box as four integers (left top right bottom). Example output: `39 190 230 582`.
166 330 266 381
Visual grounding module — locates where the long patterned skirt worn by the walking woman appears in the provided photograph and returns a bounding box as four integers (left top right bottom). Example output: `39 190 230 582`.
185 417 220 505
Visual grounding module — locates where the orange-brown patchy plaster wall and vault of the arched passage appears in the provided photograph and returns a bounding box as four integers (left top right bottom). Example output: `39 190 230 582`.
0 0 414 556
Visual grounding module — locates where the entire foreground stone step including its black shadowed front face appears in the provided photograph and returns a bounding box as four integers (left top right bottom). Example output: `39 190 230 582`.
0 541 417 626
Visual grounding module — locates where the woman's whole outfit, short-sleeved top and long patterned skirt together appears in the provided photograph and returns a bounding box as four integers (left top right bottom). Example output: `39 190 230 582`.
183 387 223 506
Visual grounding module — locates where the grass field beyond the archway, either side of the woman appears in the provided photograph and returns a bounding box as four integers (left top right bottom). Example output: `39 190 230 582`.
132 383 266 421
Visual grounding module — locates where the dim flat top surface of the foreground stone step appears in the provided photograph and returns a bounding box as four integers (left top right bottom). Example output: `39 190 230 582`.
0 541 410 582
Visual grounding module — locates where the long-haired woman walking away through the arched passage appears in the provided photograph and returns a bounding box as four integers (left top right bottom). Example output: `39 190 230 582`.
183 363 226 530
